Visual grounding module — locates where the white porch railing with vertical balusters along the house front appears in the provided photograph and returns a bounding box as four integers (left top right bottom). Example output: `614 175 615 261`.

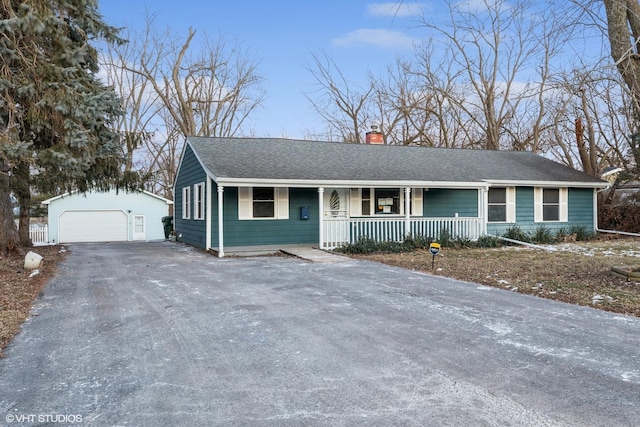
323 217 483 249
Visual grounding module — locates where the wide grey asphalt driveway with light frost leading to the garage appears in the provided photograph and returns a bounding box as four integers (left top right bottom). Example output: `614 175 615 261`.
0 242 640 427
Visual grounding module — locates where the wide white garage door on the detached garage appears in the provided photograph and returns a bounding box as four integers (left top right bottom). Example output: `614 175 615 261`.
58 211 128 243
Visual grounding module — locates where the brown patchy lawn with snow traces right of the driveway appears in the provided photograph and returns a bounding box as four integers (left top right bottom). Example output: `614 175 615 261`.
352 238 640 317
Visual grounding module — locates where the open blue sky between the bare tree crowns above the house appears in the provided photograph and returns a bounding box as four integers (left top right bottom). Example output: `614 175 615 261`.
99 0 430 138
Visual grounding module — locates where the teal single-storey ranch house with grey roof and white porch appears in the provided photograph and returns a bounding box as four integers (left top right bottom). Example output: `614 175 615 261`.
174 137 607 256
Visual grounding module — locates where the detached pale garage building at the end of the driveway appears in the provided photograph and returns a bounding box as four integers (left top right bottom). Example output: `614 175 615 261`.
42 190 173 243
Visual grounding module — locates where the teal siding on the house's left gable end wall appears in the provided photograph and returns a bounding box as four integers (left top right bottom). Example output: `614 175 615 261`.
173 145 207 248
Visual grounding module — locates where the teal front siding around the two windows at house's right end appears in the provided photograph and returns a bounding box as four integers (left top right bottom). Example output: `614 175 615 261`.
487 187 595 235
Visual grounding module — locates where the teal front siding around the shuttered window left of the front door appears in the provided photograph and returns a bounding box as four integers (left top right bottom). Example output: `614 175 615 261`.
211 187 320 247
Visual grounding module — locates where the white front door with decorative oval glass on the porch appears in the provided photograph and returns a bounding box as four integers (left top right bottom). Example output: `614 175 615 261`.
323 188 349 246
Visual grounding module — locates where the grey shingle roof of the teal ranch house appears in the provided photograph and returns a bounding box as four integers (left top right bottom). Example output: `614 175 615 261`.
187 137 604 187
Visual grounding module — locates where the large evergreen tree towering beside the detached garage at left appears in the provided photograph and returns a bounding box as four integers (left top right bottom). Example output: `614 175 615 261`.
0 0 131 252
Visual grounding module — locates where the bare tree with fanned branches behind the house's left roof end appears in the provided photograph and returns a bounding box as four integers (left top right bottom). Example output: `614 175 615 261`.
127 20 264 136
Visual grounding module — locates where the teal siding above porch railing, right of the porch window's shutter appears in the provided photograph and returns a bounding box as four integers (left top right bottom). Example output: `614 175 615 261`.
423 188 478 218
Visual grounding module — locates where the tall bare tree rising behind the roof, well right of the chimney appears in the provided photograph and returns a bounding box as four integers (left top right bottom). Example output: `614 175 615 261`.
416 0 551 150
